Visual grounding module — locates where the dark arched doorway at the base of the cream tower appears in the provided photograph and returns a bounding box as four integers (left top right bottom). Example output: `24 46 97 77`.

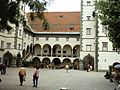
83 54 94 70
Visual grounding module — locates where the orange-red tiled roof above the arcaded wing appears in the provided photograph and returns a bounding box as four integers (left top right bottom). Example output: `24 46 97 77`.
27 12 80 32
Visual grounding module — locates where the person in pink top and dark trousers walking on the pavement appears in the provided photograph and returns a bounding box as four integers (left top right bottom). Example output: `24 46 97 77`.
33 67 39 87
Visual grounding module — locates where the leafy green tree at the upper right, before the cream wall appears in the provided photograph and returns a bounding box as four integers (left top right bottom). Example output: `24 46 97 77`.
97 0 120 50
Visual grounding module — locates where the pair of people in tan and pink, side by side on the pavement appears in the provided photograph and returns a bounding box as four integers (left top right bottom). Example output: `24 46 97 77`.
18 67 39 87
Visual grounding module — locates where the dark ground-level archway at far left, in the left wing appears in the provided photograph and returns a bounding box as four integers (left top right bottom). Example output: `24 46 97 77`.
3 51 13 67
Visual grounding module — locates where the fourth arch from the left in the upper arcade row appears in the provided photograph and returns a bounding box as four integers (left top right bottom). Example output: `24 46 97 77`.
63 45 72 57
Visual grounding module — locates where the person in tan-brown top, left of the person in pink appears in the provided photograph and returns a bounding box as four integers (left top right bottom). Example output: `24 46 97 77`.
18 67 26 86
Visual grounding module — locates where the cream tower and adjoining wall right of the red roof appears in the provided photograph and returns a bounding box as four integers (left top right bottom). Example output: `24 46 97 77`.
80 0 120 71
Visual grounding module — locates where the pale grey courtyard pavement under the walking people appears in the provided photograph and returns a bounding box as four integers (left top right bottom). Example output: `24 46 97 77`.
0 68 117 90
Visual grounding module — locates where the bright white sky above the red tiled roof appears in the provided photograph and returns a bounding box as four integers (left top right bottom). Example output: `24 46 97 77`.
26 0 81 12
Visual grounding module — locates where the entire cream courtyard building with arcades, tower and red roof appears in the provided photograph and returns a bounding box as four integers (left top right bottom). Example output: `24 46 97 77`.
0 0 120 71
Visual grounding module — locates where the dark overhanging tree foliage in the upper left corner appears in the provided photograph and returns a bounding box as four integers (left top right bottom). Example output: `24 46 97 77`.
0 0 51 30
